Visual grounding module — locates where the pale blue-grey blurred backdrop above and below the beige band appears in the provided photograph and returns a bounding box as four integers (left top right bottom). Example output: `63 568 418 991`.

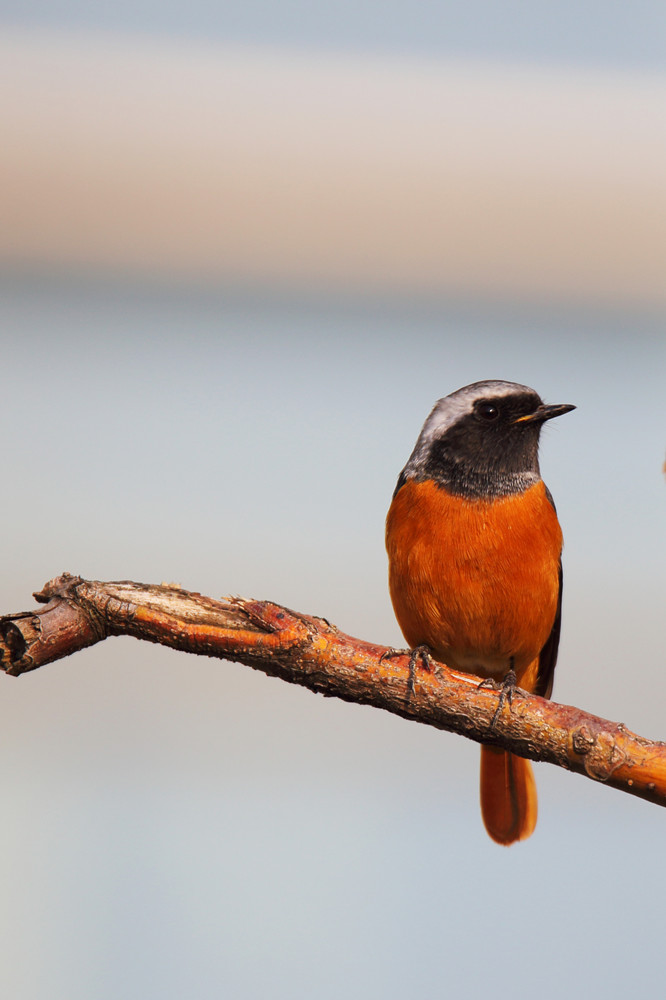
0 7 666 1000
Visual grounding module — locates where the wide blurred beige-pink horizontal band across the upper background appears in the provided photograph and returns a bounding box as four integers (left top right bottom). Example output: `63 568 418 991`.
0 30 666 308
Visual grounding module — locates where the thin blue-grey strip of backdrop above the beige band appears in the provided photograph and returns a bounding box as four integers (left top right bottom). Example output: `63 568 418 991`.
0 0 666 71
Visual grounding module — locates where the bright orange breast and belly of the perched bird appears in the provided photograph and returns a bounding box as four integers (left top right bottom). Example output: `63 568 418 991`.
386 480 562 683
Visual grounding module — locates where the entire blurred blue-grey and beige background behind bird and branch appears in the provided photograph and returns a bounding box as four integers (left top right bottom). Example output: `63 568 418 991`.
0 0 666 1000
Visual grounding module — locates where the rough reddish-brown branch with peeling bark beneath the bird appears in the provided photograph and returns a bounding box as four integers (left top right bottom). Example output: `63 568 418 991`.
0 573 666 805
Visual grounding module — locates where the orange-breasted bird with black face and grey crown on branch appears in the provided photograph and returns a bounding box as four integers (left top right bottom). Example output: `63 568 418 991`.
386 379 575 846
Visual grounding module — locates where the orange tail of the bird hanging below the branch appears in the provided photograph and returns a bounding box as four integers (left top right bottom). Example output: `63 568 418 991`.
481 746 537 846
